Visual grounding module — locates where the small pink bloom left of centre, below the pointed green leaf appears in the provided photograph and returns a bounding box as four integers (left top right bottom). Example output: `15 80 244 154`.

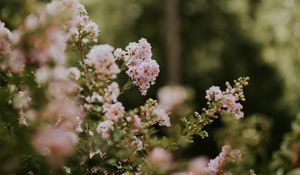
103 102 125 121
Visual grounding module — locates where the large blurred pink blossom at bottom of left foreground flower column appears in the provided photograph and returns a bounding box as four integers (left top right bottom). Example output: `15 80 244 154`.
33 126 78 166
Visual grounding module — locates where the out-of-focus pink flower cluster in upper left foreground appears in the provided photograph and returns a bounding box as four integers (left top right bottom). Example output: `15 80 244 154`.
9 13 66 73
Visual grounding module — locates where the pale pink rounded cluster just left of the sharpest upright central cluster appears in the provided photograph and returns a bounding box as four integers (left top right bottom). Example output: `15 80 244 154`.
84 44 120 80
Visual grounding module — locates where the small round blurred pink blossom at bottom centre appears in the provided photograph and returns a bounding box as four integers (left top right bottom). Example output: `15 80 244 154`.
148 147 173 170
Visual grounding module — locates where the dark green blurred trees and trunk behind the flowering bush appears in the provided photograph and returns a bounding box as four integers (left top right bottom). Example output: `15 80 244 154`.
0 0 300 173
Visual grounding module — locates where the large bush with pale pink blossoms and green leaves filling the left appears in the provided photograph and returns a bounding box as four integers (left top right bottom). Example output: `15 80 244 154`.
0 0 253 175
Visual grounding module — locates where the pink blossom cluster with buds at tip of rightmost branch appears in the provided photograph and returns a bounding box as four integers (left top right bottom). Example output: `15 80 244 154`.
205 78 248 119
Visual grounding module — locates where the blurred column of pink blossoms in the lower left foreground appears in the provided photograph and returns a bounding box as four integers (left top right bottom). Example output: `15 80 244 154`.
32 66 84 166
